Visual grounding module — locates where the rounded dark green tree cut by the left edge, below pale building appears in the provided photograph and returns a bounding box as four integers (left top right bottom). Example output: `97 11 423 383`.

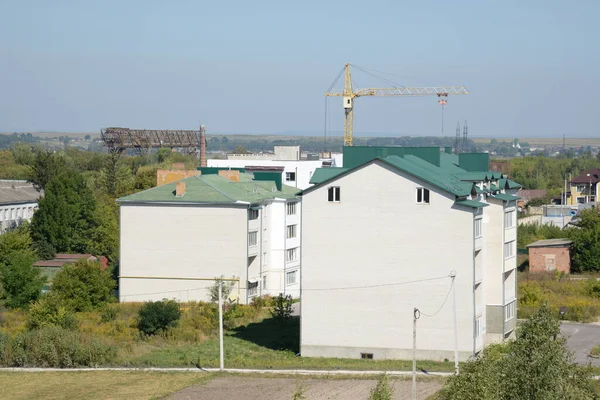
0 252 46 308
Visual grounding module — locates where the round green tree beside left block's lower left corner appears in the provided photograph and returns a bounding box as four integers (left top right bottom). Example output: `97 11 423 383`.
50 260 116 312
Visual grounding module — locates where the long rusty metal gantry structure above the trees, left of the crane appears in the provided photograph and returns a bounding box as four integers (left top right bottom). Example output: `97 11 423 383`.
100 125 206 154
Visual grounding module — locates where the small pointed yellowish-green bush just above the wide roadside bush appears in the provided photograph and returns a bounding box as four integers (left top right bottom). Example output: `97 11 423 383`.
27 294 77 330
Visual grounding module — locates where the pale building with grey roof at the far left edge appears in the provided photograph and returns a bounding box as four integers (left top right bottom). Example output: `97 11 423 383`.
0 180 42 234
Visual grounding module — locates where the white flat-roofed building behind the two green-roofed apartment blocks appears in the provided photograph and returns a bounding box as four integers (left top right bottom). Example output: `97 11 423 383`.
207 146 342 189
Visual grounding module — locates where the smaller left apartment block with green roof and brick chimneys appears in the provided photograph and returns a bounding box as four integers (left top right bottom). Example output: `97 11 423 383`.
118 168 302 303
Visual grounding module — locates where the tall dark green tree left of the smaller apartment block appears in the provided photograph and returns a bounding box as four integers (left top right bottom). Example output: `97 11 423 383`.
31 169 98 253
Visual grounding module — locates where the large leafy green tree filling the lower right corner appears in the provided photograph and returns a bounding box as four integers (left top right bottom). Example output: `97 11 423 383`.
438 306 596 400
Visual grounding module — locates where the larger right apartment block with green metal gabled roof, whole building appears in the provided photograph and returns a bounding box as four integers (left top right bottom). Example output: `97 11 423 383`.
300 147 519 360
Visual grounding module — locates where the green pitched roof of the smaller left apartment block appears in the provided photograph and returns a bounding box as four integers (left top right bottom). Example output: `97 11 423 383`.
117 174 298 204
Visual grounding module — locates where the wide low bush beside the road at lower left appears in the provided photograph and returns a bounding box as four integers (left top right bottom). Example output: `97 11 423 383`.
4 326 116 368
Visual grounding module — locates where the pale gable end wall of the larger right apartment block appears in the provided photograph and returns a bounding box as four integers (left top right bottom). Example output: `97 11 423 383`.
301 163 475 359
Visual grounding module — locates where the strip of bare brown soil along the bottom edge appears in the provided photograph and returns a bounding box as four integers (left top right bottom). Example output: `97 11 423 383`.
169 376 442 400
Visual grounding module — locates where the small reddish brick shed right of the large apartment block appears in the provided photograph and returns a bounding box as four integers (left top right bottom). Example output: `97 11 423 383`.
527 239 573 274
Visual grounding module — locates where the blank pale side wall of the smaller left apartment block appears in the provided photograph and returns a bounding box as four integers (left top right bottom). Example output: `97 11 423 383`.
119 204 248 302
